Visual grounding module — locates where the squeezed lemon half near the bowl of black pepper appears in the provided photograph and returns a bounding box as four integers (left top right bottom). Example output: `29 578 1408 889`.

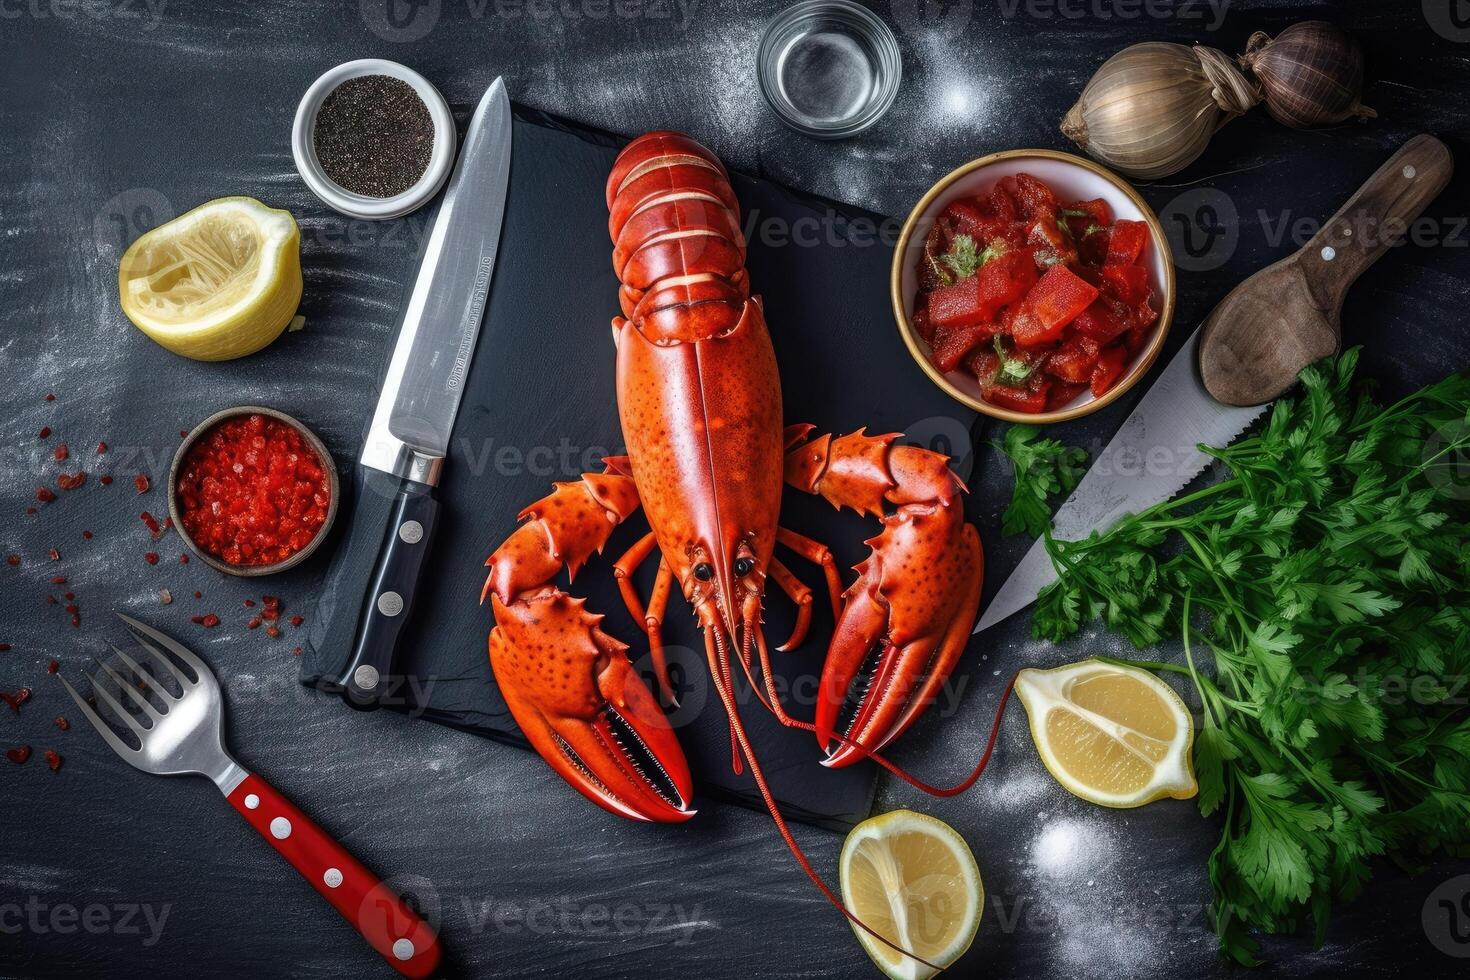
118 197 301 360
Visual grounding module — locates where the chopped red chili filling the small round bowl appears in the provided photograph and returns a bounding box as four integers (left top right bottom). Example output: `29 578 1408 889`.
178 414 331 567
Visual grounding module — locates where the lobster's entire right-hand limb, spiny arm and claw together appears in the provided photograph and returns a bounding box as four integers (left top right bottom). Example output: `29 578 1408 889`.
785 426 985 767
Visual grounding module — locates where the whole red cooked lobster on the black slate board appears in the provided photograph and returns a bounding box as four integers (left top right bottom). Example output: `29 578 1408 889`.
481 132 983 928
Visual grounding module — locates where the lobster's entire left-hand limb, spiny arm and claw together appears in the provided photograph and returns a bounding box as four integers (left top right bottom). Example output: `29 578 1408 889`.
481 460 694 821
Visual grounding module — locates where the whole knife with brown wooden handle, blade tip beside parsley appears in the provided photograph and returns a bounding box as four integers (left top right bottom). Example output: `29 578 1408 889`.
975 135 1454 633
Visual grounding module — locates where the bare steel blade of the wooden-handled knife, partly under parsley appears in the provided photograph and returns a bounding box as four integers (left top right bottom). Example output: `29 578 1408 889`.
975 329 1270 633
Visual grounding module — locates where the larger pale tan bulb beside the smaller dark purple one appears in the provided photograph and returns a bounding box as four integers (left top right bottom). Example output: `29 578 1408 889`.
1061 41 1260 179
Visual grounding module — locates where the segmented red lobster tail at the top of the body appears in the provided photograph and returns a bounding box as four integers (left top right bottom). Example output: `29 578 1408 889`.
607 132 750 341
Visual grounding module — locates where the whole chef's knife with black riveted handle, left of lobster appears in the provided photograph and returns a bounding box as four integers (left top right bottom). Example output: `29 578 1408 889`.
309 78 512 708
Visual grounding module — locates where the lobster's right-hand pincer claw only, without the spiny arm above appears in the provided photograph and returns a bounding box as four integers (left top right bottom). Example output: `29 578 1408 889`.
816 510 983 768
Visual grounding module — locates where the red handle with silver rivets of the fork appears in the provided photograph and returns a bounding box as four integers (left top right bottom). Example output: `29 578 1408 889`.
229 774 440 977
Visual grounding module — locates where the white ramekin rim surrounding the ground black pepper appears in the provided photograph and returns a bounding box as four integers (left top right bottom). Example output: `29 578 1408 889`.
291 57 456 220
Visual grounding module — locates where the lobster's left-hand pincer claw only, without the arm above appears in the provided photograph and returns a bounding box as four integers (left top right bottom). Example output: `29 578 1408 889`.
490 588 695 823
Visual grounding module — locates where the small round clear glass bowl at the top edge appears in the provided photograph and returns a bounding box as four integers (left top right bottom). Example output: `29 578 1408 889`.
757 0 903 140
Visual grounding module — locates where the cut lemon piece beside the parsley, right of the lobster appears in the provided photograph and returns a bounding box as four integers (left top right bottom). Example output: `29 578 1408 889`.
1016 660 1200 807
